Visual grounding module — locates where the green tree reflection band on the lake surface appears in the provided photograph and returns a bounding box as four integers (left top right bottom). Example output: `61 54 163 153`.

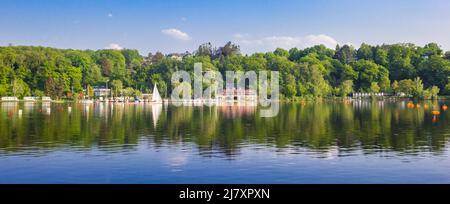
0 101 450 155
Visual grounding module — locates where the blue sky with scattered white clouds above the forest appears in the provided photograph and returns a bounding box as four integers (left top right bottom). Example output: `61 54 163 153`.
0 0 450 55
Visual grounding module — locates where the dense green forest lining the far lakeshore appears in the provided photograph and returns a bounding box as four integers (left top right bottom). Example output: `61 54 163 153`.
0 42 450 99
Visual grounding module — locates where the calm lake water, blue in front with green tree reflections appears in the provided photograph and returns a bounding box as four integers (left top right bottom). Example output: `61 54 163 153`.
0 101 450 183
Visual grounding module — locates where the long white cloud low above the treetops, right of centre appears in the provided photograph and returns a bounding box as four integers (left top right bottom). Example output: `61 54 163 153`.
233 33 338 52
